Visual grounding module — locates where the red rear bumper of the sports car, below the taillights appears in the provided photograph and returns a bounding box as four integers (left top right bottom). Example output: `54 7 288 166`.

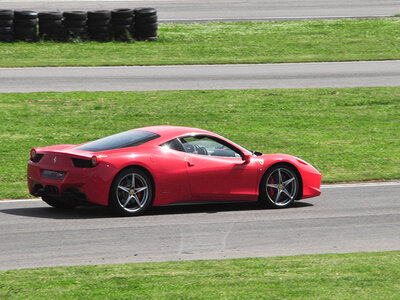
27 161 117 206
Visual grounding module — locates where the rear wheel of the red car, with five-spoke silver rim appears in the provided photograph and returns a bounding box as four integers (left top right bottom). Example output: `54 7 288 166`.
108 167 154 216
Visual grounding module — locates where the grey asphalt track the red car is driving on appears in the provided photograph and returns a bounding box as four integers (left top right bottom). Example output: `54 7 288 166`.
0 182 400 270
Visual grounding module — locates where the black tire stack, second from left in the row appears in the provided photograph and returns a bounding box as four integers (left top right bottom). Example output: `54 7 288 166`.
14 10 38 42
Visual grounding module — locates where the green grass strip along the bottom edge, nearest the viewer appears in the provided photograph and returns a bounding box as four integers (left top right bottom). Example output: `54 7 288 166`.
0 251 400 300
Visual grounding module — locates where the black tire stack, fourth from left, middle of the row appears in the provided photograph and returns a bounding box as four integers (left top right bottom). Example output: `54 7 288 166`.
63 10 87 40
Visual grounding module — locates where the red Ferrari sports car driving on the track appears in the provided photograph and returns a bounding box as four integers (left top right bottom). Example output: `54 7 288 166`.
28 126 321 216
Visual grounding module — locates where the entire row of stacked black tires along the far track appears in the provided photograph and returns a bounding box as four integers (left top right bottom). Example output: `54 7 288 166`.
0 8 158 42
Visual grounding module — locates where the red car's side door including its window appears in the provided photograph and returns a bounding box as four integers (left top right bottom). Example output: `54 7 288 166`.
180 135 259 201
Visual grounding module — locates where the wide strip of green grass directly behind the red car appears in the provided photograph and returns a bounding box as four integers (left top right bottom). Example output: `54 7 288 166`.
0 87 400 199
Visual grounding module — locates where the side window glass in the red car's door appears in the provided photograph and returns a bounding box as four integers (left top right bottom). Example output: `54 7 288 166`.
180 136 241 157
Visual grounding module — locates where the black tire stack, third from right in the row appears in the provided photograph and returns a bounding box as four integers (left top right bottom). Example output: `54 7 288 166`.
87 10 111 42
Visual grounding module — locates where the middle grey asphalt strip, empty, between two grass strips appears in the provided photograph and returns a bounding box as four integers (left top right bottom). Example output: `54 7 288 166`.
0 60 400 92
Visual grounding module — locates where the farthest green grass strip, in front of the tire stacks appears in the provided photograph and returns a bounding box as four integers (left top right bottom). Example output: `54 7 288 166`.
0 18 400 67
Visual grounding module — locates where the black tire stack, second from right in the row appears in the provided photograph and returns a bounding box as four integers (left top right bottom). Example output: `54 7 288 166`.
111 8 133 41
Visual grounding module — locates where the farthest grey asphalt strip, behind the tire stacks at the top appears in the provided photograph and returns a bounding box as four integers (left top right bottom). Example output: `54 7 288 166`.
0 0 400 22
